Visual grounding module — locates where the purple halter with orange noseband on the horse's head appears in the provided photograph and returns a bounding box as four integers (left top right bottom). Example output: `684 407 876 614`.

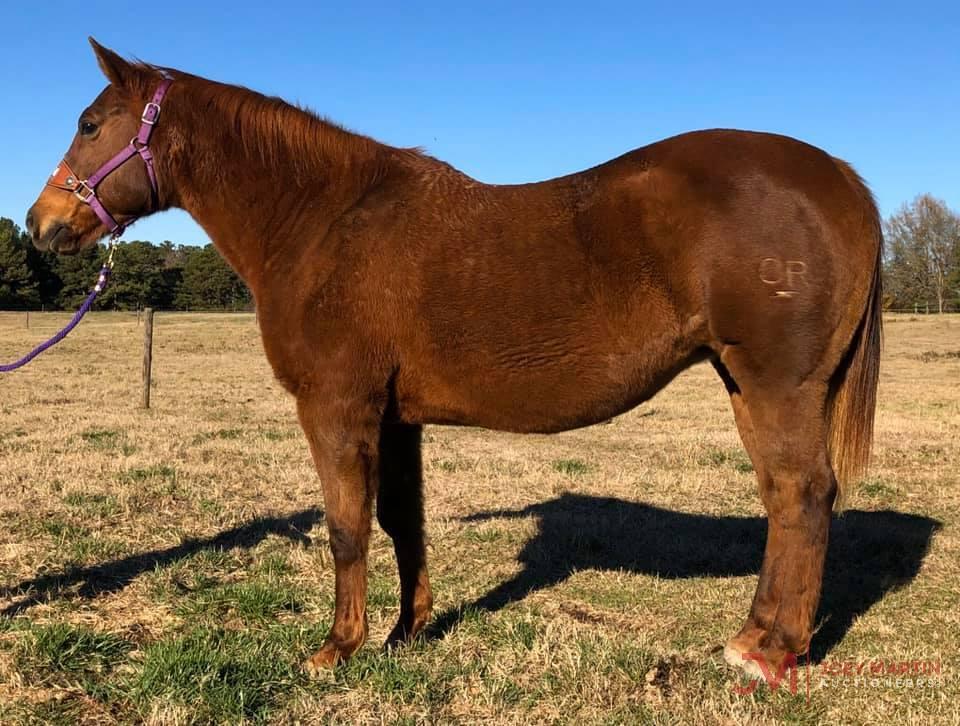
47 78 173 239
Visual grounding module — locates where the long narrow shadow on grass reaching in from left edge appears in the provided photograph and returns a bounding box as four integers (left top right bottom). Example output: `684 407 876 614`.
0 508 323 617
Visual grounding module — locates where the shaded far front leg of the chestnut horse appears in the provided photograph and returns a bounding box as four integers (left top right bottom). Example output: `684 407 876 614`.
377 424 433 648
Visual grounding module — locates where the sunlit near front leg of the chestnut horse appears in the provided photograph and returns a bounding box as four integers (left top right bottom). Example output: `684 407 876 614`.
297 396 379 674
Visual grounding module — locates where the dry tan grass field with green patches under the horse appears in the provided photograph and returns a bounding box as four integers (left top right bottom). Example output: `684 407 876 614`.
0 313 960 724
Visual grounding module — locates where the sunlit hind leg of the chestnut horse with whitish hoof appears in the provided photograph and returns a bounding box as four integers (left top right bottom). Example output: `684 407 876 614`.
717 361 837 677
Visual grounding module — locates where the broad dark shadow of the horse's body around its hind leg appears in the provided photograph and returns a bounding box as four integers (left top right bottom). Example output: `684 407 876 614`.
426 494 941 662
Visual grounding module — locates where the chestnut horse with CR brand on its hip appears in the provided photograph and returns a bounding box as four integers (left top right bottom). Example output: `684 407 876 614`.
27 39 882 673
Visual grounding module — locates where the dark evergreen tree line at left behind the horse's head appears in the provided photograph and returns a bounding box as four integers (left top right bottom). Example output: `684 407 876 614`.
0 217 253 310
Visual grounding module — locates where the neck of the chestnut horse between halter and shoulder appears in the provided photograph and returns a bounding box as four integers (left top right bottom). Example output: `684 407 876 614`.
160 81 388 296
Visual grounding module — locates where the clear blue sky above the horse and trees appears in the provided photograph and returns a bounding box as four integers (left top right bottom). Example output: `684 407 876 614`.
0 0 960 244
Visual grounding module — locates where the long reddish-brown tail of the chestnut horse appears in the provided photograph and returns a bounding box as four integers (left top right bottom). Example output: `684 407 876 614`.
827 160 883 503
